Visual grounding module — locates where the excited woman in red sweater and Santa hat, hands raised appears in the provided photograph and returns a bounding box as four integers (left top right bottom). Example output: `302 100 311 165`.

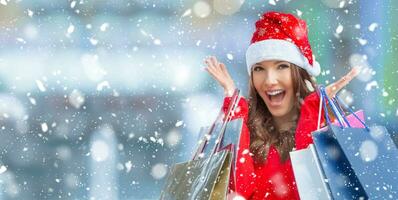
205 12 358 199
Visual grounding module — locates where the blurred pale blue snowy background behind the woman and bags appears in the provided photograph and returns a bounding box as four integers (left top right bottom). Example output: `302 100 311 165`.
0 0 398 200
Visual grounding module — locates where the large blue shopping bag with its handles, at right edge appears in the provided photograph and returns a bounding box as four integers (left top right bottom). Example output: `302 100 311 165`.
313 85 398 199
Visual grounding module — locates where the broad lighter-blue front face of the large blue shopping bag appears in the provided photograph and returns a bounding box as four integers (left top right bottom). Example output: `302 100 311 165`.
331 126 398 199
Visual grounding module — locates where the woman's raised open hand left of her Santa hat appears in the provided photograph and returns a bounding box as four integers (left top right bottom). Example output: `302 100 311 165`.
205 56 235 96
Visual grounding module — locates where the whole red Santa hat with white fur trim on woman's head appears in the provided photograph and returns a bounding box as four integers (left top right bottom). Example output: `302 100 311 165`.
246 12 321 76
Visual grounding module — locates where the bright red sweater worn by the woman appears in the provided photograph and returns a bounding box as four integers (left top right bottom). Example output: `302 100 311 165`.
223 92 324 200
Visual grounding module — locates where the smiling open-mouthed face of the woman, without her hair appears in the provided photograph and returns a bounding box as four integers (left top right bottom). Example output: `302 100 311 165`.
252 60 295 119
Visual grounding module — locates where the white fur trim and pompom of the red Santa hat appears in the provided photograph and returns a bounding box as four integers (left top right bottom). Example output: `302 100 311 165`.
246 39 321 76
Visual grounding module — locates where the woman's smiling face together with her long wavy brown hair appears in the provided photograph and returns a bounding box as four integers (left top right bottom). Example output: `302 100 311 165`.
248 60 315 163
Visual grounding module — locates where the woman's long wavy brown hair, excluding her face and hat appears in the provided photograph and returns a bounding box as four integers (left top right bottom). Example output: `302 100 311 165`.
247 64 316 163
